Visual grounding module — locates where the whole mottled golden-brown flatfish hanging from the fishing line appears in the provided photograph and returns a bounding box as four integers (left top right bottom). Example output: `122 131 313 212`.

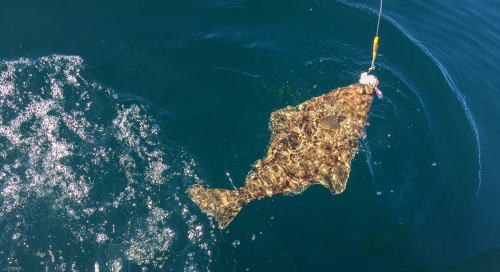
188 83 372 229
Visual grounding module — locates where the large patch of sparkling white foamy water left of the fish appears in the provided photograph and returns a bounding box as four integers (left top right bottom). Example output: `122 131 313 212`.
0 55 216 271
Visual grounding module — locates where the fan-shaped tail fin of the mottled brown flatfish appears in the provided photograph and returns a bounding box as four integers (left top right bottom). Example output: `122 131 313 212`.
188 186 250 229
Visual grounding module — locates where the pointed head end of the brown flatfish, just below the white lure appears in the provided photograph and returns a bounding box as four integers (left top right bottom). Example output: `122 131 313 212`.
341 83 373 118
